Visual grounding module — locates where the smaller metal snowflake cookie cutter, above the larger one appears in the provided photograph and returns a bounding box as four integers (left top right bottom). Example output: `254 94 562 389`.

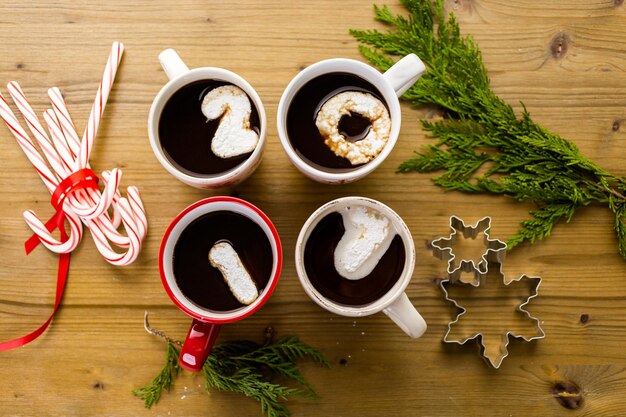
431 216 506 287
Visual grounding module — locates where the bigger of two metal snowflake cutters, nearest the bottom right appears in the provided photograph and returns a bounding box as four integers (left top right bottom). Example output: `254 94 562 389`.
439 264 545 369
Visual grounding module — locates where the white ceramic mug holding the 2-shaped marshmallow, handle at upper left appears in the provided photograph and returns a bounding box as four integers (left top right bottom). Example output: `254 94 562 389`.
148 49 267 188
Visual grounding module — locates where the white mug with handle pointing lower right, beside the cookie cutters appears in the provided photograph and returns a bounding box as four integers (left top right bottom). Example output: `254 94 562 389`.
295 197 426 338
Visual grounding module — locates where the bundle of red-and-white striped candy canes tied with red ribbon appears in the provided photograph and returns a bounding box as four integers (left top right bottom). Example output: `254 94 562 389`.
0 42 147 265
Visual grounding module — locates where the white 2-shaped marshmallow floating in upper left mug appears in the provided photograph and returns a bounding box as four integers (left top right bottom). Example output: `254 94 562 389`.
201 85 259 158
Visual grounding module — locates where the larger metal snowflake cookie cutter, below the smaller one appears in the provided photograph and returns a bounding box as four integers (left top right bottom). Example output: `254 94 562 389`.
439 264 546 369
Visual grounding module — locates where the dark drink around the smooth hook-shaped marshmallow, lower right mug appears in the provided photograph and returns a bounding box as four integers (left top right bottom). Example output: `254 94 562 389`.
304 212 405 306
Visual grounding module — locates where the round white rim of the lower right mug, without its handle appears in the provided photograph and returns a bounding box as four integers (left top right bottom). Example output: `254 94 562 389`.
295 196 416 317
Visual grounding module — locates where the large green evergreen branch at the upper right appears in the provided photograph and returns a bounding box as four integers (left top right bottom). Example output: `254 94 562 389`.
350 0 626 258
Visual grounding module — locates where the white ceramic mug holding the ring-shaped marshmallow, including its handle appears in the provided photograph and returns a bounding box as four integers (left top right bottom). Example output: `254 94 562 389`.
276 54 426 184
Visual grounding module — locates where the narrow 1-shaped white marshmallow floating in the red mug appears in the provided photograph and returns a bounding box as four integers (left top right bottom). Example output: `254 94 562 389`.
209 242 259 305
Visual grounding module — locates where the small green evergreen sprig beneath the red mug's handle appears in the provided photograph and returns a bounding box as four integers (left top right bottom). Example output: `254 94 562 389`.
133 336 329 417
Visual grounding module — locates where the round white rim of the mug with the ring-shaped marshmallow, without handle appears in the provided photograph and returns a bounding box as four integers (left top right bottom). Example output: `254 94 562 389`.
276 58 402 183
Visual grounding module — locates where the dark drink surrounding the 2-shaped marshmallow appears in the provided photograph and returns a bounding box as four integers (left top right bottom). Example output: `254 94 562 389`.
159 80 260 177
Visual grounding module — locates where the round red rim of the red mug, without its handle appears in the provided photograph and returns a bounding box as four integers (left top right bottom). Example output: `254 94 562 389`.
158 196 283 324
